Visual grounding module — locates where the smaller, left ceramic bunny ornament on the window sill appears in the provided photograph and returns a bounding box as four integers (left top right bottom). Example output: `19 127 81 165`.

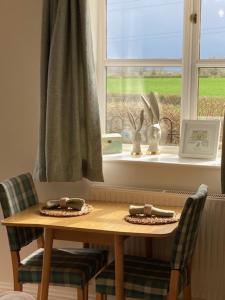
128 109 144 155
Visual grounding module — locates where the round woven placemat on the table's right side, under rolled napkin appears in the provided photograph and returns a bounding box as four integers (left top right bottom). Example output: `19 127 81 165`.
124 213 180 225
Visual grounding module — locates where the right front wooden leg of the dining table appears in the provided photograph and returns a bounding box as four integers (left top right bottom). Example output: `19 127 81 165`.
114 235 124 300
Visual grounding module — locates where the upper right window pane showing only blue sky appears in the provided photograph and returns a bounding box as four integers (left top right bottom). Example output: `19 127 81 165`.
200 0 225 59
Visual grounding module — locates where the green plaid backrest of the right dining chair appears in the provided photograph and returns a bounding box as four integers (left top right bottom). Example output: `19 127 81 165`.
171 184 208 270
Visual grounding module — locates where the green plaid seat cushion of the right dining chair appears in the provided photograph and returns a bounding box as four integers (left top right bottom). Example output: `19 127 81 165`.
96 255 187 300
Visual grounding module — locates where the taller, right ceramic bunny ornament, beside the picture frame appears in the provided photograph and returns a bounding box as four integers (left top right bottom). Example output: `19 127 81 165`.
141 92 161 154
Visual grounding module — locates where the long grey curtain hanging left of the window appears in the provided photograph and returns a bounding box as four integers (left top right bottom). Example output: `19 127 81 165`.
34 0 103 181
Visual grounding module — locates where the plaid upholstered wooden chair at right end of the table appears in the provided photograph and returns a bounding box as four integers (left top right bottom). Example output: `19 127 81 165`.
96 184 207 300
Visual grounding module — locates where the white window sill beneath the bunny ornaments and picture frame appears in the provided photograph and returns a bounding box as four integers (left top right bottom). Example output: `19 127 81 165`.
103 152 221 168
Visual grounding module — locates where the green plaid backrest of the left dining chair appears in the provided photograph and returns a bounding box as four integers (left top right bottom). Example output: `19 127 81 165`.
0 173 43 251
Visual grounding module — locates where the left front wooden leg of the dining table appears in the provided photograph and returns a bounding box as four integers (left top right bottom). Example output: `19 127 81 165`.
40 228 53 300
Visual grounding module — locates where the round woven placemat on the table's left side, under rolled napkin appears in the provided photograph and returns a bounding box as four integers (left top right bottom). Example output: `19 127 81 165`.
40 204 93 217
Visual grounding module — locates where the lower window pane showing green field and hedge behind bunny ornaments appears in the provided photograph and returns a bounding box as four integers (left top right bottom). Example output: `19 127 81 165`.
106 67 181 144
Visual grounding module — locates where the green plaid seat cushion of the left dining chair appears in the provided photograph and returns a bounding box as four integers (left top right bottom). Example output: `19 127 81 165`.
19 248 107 287
